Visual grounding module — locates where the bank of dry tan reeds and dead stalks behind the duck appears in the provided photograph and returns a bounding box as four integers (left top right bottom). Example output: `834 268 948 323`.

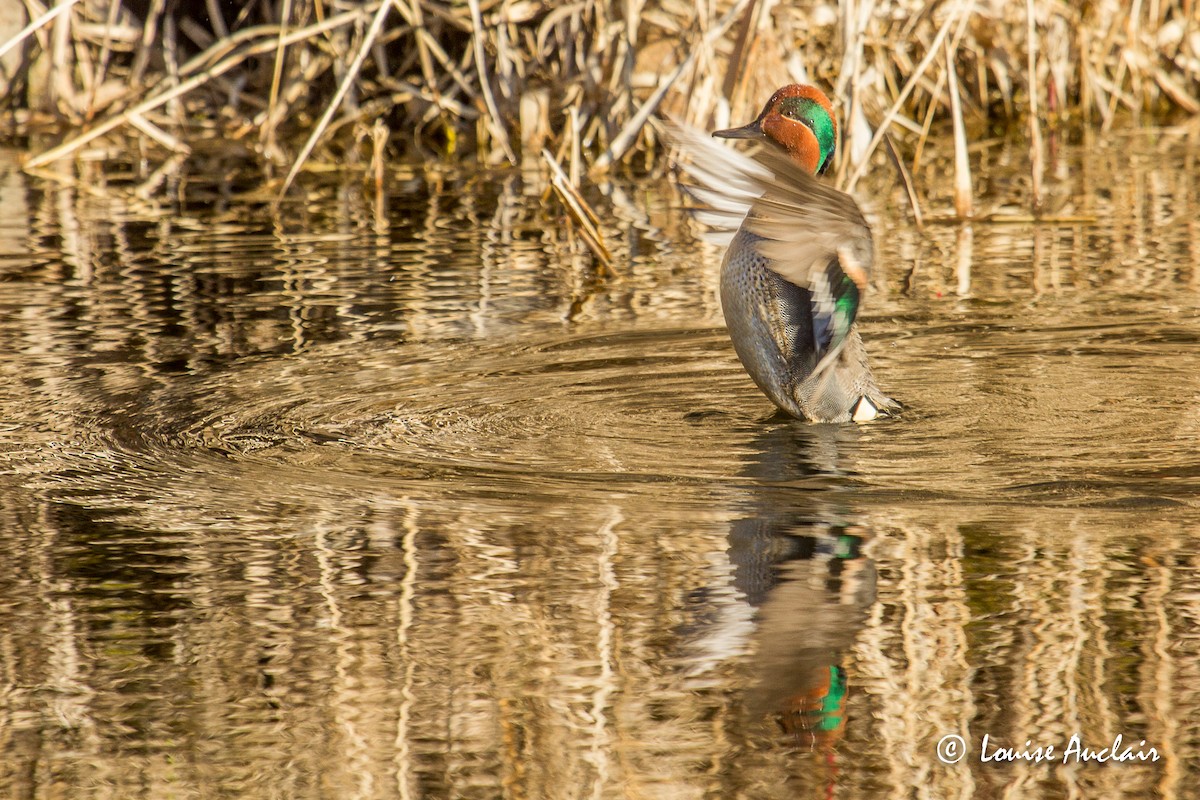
0 0 1200 200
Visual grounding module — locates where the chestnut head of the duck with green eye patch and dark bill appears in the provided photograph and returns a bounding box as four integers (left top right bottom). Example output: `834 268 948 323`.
713 83 838 175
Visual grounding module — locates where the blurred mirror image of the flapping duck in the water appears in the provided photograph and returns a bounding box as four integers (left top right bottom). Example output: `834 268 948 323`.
689 422 876 760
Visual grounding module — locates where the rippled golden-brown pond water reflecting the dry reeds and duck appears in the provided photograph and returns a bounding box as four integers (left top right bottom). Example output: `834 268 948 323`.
0 133 1200 800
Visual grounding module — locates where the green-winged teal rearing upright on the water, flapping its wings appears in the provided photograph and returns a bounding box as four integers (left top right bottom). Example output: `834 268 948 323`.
670 84 899 422
